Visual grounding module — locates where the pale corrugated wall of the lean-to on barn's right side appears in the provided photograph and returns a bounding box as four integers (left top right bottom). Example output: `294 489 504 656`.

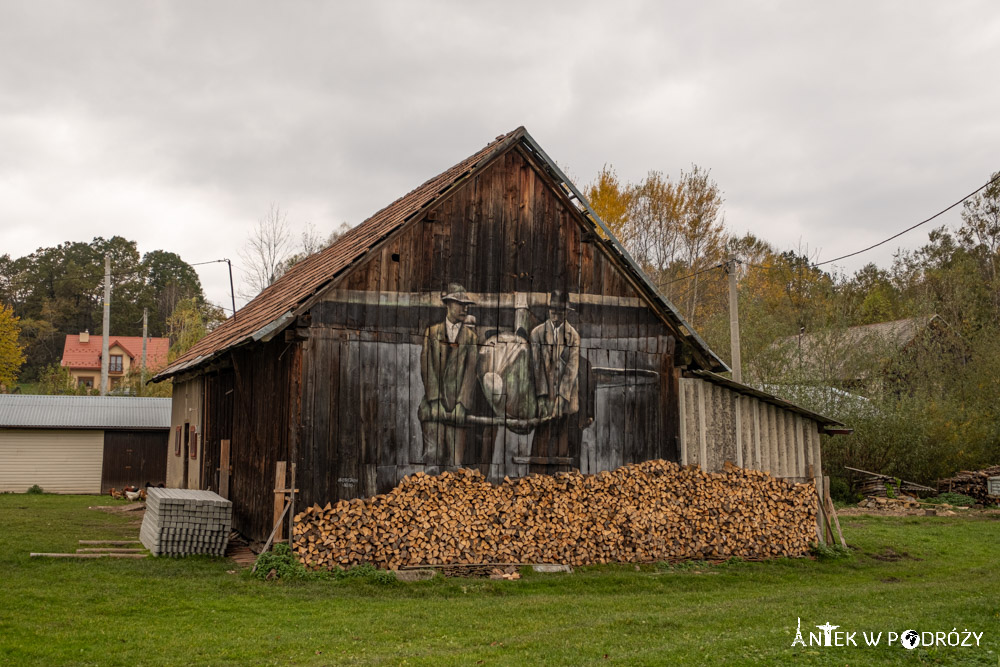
680 378 823 480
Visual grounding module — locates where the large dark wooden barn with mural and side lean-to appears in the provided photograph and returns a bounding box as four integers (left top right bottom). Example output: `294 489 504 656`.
154 128 841 539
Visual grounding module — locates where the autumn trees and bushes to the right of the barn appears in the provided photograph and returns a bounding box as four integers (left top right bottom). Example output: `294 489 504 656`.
586 166 1000 495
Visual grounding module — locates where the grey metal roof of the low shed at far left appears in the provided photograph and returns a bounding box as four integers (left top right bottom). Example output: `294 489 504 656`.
0 394 170 430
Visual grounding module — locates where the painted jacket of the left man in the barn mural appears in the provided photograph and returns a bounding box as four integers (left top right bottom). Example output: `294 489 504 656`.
420 322 479 412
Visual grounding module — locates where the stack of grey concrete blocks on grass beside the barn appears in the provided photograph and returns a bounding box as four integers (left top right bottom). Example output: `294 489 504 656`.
139 487 233 556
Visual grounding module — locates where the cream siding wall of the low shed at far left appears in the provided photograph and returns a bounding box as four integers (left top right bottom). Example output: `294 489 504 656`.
0 429 104 493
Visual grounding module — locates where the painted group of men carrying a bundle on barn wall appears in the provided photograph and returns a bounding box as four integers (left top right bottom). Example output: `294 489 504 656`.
417 283 593 477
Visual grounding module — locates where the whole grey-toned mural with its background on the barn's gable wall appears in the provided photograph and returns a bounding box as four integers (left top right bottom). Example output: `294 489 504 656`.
312 283 674 492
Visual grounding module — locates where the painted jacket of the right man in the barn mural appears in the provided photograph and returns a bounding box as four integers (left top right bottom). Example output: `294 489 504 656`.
531 320 580 414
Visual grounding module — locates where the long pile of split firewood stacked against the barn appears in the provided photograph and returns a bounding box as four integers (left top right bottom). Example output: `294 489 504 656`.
293 461 817 569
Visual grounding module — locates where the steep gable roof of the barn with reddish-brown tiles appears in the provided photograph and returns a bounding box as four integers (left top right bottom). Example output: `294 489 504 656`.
158 126 729 382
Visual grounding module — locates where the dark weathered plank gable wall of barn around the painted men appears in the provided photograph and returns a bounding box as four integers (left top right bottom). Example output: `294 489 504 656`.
296 148 678 503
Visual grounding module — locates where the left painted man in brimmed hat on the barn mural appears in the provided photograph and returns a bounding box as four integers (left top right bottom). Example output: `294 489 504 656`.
417 283 479 465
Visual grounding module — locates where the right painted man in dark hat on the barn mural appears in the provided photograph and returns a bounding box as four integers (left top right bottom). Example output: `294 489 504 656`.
530 290 580 471
